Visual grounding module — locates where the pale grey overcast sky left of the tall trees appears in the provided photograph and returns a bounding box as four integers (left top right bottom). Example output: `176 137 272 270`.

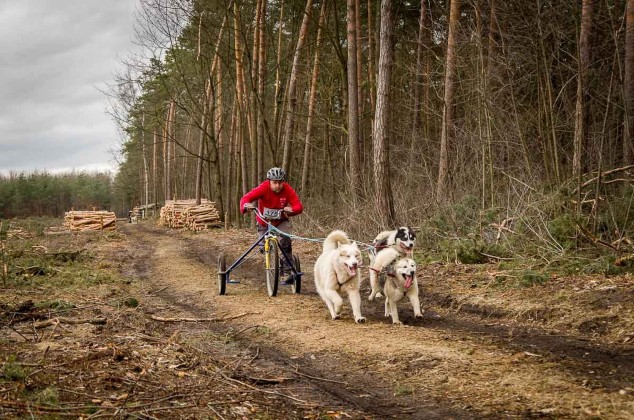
0 0 137 174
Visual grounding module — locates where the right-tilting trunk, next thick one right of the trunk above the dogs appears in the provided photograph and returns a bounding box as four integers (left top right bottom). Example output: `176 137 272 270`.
436 0 460 201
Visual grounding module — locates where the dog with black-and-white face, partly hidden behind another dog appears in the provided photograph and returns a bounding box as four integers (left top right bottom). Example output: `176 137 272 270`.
368 226 416 300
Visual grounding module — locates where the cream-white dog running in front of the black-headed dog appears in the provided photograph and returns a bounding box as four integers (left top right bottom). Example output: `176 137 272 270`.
380 258 423 324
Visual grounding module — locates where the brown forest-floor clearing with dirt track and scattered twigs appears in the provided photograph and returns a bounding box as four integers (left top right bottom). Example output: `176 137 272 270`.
0 222 634 419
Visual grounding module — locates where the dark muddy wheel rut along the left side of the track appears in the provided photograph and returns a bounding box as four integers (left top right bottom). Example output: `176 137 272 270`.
121 225 472 419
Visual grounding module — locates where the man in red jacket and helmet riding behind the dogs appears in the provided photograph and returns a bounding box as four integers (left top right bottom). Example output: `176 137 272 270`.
240 167 304 274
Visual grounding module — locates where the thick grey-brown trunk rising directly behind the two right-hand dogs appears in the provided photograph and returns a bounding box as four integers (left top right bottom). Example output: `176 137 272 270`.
372 0 396 228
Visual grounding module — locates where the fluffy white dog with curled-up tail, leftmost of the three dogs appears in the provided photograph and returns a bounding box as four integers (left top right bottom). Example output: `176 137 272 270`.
315 230 365 323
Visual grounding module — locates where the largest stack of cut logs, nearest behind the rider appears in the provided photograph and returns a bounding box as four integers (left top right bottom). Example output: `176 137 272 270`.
159 199 220 231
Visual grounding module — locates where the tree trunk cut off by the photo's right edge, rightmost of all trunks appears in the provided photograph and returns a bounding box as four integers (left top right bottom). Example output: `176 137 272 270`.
623 0 634 165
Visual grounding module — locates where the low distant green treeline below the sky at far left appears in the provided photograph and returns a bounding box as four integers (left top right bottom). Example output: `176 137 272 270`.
0 172 113 219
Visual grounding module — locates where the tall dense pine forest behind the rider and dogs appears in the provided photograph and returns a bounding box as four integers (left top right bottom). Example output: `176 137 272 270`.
111 0 634 260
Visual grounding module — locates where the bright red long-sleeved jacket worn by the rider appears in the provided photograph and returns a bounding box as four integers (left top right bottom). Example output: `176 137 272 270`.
240 179 304 226
